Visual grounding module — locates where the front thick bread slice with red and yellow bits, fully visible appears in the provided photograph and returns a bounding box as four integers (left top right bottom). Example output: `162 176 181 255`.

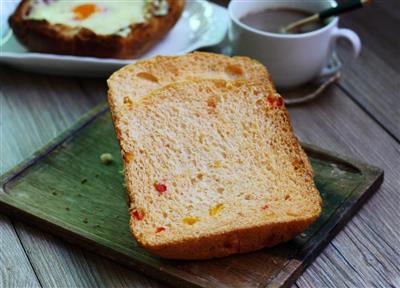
117 80 321 259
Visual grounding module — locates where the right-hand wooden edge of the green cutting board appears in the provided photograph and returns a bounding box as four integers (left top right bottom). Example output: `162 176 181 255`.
264 163 384 288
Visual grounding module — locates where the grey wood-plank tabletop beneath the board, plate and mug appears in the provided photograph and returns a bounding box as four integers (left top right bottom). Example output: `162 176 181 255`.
0 0 400 287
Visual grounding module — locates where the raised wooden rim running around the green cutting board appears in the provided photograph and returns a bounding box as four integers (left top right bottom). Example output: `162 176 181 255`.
0 101 383 287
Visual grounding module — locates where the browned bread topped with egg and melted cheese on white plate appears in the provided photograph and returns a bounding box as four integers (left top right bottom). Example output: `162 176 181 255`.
9 0 184 58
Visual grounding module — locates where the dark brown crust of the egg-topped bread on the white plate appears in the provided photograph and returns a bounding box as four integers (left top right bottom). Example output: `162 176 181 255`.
9 0 185 59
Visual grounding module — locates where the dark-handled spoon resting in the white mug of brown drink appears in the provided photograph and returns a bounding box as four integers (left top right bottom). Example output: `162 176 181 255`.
280 0 372 33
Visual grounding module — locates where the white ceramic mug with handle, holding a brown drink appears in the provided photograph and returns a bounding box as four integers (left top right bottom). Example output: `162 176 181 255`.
228 0 361 89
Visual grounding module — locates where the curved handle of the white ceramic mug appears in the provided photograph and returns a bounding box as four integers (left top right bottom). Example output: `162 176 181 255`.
319 27 361 77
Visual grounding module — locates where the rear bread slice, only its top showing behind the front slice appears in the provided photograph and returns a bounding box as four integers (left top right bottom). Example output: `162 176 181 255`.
107 52 272 115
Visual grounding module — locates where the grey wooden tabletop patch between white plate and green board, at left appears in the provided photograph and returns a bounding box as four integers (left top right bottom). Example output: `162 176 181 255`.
0 66 105 173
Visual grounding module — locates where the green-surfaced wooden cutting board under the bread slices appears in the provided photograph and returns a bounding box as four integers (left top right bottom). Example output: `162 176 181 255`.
0 104 383 287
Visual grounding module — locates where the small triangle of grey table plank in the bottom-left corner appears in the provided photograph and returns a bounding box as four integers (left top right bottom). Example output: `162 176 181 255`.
0 215 40 288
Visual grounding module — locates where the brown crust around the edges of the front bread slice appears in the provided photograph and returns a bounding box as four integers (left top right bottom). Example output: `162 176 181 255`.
120 80 322 260
